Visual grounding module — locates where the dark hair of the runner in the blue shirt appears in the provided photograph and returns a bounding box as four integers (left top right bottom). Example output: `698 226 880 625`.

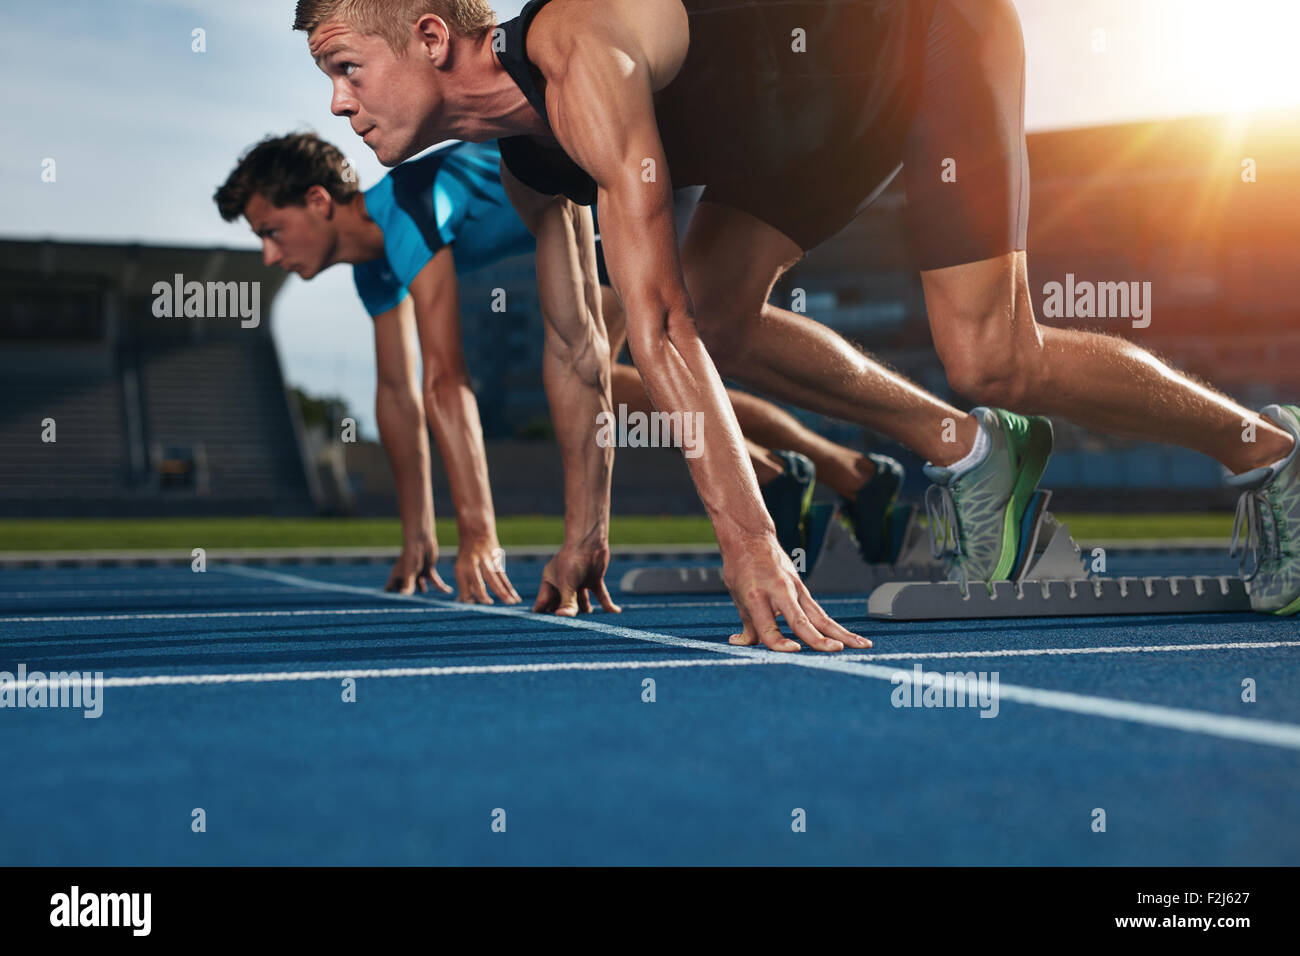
212 133 359 222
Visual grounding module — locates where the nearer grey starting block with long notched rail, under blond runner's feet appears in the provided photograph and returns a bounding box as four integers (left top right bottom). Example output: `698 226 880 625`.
867 492 1251 620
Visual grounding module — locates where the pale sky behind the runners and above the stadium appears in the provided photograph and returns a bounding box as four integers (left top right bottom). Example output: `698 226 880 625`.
0 0 1300 433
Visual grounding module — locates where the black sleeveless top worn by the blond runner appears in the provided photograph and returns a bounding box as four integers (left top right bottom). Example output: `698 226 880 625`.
497 0 939 206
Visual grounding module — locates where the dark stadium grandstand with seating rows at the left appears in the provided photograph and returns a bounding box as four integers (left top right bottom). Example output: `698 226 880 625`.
0 239 319 516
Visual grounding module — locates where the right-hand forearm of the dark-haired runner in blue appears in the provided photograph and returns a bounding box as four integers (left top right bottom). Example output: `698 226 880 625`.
424 376 497 537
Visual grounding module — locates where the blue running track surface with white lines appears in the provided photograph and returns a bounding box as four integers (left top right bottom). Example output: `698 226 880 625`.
0 557 1300 865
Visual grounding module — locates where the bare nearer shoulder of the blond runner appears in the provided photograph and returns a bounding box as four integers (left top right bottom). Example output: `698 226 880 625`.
528 0 690 90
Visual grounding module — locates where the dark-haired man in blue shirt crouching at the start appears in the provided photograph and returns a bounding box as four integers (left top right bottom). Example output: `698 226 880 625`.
215 133 897 604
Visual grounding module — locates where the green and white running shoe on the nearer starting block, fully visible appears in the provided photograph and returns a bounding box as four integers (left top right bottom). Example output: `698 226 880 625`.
924 407 1052 585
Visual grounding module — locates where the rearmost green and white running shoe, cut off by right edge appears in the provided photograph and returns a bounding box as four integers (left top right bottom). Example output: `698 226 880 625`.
1227 405 1300 617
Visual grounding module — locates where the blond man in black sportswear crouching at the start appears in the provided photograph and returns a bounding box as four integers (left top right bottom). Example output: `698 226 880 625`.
295 0 1300 650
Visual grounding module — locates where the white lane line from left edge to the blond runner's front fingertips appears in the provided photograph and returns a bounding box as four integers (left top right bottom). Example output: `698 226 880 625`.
8 657 759 692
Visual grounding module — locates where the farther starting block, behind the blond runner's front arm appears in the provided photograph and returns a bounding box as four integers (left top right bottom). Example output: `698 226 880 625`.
619 503 944 594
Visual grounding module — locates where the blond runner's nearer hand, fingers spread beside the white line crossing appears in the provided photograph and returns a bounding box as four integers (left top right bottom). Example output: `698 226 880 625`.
723 535 871 650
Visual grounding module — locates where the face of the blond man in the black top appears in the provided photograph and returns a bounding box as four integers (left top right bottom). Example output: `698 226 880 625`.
307 16 447 166
